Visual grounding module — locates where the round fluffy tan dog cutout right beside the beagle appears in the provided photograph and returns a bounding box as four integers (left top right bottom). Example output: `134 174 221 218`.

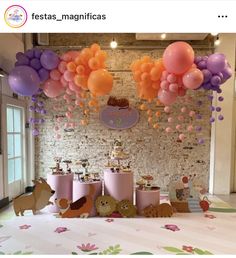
95 195 117 217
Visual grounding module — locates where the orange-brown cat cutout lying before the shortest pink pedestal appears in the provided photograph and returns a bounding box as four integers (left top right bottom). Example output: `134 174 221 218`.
142 203 173 218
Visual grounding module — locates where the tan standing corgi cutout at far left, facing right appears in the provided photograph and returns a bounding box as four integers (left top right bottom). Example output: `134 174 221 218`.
13 178 55 216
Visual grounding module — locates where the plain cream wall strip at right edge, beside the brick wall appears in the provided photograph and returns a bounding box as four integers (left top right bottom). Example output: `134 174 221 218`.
210 34 236 194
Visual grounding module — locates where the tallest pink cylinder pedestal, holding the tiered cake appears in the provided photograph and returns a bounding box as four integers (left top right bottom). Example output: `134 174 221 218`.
104 170 134 203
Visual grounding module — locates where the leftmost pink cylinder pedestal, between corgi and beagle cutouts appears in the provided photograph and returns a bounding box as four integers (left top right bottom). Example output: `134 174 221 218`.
47 173 74 213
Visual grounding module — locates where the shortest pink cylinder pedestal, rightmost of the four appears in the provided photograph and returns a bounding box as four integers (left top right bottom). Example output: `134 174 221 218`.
136 188 160 215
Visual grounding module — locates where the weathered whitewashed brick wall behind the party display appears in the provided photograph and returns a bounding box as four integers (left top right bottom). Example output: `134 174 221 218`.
35 34 211 190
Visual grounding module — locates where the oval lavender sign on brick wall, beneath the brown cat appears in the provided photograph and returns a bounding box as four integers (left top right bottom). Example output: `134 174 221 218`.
100 105 139 130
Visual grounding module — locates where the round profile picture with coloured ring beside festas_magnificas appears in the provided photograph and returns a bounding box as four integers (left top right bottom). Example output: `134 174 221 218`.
4 5 28 28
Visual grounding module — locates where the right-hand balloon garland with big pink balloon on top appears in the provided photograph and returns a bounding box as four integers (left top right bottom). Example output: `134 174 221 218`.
131 41 232 144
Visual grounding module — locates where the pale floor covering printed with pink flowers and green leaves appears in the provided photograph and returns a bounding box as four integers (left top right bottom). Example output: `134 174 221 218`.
0 210 236 255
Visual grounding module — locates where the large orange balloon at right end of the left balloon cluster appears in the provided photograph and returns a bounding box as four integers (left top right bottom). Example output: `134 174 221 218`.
88 69 113 96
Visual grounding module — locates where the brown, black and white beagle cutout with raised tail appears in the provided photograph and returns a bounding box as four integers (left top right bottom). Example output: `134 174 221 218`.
55 185 95 218
